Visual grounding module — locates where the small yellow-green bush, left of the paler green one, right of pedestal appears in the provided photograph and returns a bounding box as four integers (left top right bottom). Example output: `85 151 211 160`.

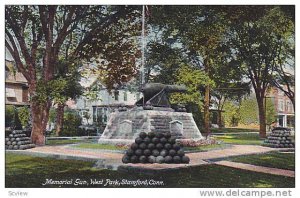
222 101 240 127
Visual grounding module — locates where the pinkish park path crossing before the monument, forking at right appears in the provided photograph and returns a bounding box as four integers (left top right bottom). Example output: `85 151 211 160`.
7 145 293 176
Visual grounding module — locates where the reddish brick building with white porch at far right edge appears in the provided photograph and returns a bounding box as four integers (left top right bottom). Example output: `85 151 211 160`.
266 87 295 128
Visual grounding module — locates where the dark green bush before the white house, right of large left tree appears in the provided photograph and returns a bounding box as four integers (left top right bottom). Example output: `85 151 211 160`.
60 111 81 136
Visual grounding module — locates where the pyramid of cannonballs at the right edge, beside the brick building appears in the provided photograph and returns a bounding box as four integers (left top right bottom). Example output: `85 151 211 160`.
264 127 295 148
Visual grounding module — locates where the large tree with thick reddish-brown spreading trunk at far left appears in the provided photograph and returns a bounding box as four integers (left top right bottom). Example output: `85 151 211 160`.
5 5 139 145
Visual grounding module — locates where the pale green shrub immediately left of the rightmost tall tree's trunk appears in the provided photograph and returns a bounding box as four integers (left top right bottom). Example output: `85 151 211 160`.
239 98 258 125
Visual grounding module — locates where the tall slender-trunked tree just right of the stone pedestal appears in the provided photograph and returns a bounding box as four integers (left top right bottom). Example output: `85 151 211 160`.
150 6 230 134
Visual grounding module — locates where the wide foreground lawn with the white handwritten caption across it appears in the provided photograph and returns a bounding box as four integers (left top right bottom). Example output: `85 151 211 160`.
5 153 295 188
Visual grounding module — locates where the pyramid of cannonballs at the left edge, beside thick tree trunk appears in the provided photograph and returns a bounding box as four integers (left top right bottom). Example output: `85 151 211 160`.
5 130 35 150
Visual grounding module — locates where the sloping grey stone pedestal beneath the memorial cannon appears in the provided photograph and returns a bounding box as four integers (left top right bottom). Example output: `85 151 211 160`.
98 107 203 144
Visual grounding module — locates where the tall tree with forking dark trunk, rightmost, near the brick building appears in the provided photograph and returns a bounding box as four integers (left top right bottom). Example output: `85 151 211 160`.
227 6 294 138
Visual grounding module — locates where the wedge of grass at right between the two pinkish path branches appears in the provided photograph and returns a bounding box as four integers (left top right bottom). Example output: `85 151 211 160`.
229 152 295 170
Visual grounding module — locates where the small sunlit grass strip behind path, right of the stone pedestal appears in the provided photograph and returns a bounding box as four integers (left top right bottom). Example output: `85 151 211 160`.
214 133 263 145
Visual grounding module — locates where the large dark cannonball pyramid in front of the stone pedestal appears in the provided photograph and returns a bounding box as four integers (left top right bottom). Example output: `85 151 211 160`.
122 132 190 164
